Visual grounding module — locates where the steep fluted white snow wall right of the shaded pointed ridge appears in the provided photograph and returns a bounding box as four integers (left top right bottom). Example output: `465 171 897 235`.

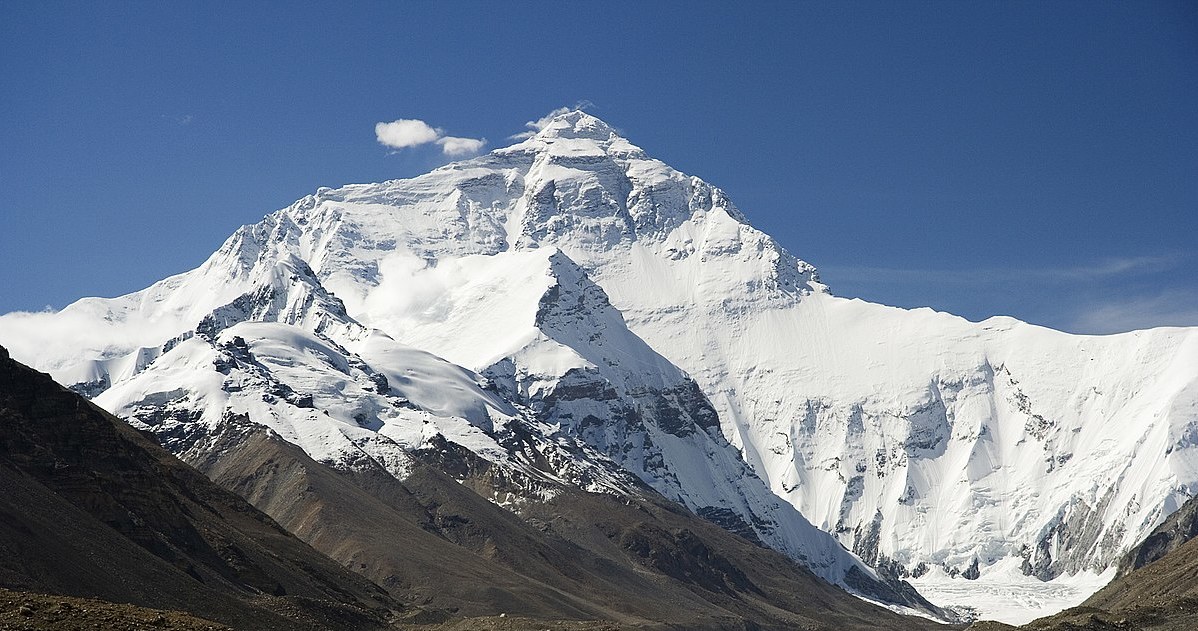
608 282 1198 580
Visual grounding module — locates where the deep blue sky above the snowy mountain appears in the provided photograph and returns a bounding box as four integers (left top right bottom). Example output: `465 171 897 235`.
0 0 1198 332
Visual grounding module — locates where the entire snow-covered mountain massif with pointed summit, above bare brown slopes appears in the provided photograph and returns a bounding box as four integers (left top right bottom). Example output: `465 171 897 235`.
0 111 1198 622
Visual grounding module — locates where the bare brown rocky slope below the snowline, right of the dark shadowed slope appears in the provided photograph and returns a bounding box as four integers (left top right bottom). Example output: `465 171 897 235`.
199 416 940 630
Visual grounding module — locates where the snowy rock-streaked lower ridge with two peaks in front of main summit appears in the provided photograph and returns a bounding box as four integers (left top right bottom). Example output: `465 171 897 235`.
0 170 905 607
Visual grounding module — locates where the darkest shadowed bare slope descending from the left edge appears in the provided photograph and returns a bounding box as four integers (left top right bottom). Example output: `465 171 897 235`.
0 348 399 630
